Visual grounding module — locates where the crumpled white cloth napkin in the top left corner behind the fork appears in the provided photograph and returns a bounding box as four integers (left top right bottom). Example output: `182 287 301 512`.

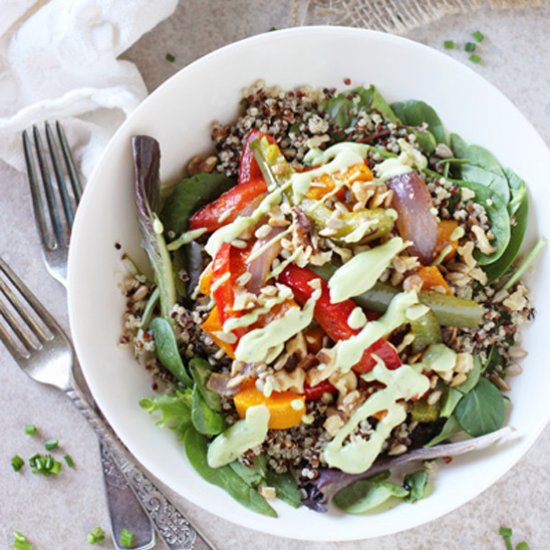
0 0 177 177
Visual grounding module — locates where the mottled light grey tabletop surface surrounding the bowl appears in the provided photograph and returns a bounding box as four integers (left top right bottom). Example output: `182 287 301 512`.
0 0 550 550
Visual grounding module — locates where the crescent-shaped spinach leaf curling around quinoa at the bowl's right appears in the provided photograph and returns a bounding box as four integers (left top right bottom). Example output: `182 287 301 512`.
458 180 511 266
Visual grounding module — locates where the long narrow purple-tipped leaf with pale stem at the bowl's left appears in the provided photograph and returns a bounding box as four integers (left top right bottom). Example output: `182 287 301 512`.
132 136 176 319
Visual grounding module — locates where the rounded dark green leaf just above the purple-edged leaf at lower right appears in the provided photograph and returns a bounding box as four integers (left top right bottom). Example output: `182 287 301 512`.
454 378 504 437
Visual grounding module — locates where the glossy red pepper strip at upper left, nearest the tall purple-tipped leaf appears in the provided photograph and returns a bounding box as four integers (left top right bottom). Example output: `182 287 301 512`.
189 176 267 233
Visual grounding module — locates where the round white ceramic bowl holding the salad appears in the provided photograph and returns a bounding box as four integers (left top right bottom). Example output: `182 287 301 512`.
69 27 550 540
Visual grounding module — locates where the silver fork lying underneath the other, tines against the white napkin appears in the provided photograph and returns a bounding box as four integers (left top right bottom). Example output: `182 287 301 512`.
19 122 213 550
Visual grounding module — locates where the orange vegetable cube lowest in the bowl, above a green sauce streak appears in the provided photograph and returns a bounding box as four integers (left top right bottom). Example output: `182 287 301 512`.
234 380 306 430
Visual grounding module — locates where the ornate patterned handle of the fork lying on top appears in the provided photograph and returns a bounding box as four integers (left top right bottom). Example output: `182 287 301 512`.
65 379 214 550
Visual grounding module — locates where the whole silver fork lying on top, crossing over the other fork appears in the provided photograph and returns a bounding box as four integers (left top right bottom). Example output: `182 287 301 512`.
0 258 213 550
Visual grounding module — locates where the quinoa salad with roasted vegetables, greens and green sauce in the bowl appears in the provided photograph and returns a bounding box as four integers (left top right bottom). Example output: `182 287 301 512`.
121 82 544 516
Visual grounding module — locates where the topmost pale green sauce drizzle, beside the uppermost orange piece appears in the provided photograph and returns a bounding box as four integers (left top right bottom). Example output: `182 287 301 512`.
290 142 368 204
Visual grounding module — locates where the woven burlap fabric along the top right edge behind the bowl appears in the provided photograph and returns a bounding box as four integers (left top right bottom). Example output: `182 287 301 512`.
292 0 546 34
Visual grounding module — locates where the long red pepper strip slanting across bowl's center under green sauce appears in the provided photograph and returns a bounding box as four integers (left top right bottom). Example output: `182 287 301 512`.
279 264 402 373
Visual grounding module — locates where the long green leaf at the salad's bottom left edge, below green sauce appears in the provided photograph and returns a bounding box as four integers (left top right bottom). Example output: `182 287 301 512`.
184 427 277 517
